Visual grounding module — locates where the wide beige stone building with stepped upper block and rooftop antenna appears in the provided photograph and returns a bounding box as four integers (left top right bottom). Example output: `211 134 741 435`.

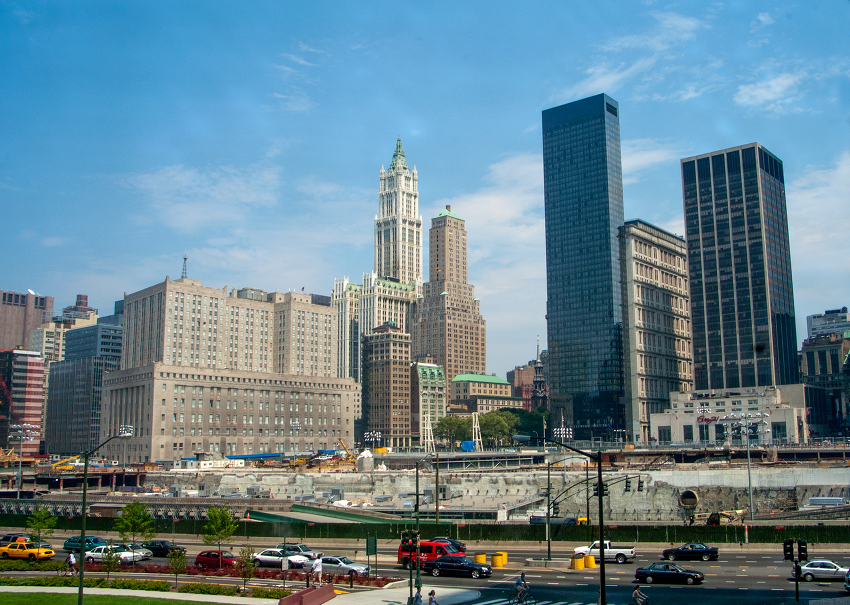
101 277 360 461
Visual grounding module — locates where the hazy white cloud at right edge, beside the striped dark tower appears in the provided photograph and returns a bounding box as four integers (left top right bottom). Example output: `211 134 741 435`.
786 150 850 340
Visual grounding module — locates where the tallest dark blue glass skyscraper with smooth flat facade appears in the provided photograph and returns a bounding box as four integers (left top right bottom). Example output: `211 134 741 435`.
543 94 625 439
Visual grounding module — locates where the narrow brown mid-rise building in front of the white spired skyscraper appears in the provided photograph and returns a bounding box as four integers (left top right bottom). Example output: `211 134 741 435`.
361 322 414 447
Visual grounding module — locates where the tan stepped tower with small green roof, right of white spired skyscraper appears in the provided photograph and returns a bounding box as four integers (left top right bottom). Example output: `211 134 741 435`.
410 206 487 396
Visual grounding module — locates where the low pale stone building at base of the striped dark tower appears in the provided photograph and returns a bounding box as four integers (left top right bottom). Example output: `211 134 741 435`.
650 384 809 447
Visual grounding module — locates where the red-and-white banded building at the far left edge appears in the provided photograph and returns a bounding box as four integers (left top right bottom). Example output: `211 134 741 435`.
0 349 45 457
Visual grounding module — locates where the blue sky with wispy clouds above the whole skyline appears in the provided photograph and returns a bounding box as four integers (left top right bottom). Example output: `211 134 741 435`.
0 0 850 375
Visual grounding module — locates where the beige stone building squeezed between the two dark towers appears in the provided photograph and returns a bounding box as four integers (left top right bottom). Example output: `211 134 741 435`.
620 220 693 444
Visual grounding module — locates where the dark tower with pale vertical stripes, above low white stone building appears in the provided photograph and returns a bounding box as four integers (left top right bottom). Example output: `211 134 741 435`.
682 143 799 391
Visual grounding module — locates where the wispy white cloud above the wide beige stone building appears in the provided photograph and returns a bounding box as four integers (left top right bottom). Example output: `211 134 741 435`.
123 166 279 232
